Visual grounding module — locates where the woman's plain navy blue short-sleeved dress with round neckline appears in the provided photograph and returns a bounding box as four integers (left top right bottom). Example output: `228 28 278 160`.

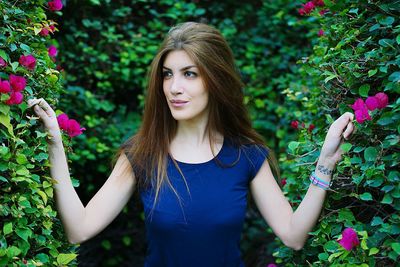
140 138 267 267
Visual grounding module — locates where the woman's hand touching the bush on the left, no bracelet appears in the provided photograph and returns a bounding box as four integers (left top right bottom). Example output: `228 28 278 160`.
28 98 62 143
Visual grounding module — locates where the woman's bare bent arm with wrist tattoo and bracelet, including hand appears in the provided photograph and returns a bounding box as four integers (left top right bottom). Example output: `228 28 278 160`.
250 112 354 250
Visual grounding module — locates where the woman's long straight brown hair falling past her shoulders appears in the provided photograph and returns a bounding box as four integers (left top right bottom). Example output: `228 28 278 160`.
117 22 279 204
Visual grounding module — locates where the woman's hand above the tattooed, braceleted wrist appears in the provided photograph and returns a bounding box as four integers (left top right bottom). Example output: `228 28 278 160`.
320 112 355 166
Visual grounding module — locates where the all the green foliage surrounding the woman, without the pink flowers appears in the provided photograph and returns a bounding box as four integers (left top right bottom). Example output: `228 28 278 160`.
0 0 400 266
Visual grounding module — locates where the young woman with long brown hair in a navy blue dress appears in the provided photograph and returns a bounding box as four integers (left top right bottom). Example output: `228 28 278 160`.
29 22 354 267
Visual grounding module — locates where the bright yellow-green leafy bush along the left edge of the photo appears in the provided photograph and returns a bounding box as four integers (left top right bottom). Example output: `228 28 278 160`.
0 1 76 266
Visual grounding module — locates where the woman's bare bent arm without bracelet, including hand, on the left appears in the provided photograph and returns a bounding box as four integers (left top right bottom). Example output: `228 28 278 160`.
29 99 135 243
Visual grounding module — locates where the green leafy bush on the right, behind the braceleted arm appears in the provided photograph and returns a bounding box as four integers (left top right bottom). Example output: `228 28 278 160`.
274 1 400 266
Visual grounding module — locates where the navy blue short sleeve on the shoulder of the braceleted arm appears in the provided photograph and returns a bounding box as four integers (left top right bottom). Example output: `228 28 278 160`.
243 145 268 181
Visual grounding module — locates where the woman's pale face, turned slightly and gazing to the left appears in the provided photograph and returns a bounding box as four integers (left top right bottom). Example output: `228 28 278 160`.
163 50 208 122
